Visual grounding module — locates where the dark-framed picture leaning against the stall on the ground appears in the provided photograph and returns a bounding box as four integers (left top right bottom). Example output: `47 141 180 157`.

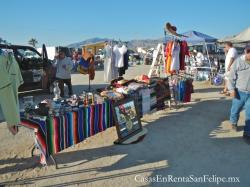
113 99 142 142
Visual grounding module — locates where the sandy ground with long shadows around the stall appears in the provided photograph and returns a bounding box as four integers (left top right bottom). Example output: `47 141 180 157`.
0 66 250 187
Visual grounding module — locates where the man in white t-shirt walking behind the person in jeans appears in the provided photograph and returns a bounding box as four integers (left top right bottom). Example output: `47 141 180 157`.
221 42 238 96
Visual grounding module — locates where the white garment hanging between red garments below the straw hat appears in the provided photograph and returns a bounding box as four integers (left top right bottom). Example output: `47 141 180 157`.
170 42 180 72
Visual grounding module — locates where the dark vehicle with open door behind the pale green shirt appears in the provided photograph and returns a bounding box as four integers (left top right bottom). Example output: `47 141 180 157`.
0 44 55 92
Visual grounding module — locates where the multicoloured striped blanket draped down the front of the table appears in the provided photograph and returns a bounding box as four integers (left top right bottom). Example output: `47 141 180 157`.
21 100 114 167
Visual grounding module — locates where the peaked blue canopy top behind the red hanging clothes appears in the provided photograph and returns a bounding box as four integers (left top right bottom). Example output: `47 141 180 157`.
182 31 217 44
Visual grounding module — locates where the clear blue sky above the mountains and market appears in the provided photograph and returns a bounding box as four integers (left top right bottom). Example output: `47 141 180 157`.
0 0 250 46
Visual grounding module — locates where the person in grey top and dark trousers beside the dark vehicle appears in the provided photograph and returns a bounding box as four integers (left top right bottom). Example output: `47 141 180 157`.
54 50 73 97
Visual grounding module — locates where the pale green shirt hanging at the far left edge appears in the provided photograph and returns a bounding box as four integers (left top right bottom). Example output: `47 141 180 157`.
0 54 22 127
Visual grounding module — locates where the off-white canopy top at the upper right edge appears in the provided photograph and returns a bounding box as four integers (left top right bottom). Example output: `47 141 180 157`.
218 27 250 43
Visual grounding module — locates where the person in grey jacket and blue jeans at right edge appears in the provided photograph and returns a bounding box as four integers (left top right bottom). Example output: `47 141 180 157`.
228 43 250 144
